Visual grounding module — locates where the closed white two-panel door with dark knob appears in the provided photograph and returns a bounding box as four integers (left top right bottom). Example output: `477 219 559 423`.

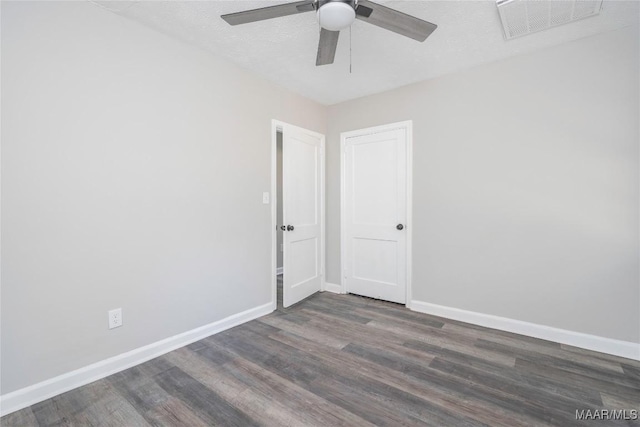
343 123 408 303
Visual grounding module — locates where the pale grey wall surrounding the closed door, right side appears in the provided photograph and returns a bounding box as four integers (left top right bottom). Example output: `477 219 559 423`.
327 27 640 342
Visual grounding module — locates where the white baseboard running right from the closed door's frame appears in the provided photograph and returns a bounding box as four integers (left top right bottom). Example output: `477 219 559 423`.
411 300 640 360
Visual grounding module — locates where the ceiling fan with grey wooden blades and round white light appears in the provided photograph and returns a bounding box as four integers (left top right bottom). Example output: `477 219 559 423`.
221 0 438 65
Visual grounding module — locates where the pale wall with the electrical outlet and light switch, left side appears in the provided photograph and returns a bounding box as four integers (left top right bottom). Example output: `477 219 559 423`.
1 2 326 394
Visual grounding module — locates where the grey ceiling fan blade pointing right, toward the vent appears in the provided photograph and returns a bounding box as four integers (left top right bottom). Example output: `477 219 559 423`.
356 0 438 42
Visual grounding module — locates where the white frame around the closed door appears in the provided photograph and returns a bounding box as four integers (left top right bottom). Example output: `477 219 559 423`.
340 120 413 308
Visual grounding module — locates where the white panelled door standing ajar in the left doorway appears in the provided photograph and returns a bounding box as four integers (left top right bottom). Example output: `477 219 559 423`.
282 125 324 307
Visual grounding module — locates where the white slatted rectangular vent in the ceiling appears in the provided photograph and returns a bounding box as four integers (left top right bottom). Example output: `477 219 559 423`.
496 0 602 40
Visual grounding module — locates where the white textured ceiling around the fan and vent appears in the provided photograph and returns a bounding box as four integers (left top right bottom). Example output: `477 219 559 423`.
95 0 640 105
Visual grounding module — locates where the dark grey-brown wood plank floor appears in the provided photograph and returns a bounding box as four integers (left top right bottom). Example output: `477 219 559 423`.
0 282 640 427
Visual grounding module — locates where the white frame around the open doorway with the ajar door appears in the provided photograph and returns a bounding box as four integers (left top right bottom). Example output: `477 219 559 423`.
271 119 326 310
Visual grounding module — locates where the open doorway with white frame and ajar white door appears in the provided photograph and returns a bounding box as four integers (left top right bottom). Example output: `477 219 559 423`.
271 120 325 310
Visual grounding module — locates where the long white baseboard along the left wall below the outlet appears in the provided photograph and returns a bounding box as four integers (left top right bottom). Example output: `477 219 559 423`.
0 303 273 416
